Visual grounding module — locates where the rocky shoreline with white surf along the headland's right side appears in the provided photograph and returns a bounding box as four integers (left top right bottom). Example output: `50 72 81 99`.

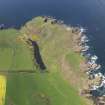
73 28 105 105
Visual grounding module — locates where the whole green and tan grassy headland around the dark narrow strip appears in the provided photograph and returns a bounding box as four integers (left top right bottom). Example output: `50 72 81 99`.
0 17 90 105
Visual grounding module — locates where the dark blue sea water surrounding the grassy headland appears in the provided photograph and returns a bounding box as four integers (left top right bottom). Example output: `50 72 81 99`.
0 0 105 71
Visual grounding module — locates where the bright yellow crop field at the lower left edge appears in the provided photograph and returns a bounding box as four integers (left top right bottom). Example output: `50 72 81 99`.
0 75 6 105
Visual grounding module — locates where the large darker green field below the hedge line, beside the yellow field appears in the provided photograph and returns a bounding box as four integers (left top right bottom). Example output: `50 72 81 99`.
6 73 85 105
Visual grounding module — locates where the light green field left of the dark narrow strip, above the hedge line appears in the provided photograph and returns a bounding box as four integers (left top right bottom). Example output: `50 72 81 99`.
0 29 33 71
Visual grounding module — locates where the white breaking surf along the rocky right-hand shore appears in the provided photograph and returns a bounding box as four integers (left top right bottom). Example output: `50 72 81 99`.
80 27 105 94
